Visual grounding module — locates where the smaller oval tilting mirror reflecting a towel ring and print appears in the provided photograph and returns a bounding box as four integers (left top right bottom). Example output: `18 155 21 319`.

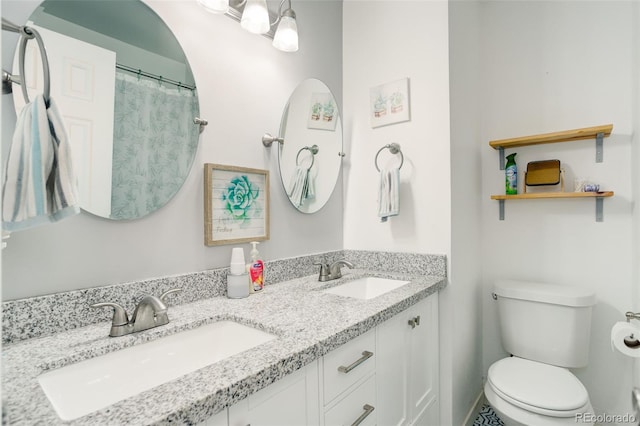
278 78 342 213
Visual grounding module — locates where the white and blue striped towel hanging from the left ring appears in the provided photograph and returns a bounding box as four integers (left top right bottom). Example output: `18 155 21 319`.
2 95 80 231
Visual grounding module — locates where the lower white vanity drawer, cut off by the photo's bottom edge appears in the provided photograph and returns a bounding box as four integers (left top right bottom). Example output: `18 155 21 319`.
324 375 377 426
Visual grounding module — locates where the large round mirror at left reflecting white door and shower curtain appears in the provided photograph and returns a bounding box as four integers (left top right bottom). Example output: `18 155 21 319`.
13 0 199 220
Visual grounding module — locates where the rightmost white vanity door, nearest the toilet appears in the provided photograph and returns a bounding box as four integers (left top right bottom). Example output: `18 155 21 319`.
408 295 439 425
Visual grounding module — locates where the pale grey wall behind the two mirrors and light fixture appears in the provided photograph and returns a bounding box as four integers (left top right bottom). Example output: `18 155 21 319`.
2 0 342 300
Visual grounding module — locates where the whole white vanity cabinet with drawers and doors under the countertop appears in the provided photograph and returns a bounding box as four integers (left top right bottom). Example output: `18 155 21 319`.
199 294 439 426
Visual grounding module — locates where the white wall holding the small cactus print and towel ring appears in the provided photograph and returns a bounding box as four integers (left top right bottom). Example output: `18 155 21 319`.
343 0 452 424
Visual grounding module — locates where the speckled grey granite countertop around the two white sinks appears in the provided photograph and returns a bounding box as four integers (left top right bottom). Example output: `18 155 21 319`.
2 268 446 425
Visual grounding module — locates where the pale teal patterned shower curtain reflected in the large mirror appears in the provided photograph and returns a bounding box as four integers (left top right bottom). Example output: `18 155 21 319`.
111 71 199 219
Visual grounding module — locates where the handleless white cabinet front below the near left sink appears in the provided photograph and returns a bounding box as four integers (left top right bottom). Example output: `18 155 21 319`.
229 361 320 426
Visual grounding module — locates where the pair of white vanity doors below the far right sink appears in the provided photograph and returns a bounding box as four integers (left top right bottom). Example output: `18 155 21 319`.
376 295 439 426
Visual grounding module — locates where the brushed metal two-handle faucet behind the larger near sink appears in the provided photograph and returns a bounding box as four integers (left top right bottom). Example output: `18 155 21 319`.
91 288 182 337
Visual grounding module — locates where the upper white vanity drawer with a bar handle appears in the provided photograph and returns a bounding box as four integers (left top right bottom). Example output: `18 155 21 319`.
323 330 376 405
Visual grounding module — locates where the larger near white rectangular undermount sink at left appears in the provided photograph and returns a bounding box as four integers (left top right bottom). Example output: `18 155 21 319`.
38 321 276 420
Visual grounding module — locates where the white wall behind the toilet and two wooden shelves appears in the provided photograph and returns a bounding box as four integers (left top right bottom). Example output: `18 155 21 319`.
479 1 638 420
